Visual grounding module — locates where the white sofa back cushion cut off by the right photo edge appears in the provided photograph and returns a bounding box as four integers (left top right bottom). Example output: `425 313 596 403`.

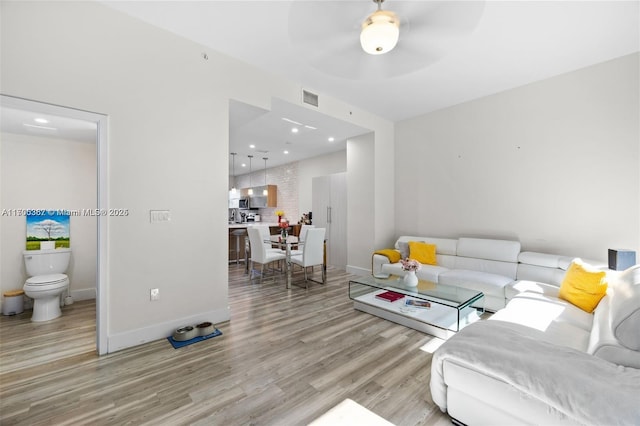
610 265 640 351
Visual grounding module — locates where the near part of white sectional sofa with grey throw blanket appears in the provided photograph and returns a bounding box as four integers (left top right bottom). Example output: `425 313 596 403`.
430 264 640 426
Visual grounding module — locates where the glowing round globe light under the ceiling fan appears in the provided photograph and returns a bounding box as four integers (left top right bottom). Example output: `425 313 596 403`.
360 10 400 55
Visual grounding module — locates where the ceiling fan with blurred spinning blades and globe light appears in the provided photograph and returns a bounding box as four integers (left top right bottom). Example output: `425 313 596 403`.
288 0 485 80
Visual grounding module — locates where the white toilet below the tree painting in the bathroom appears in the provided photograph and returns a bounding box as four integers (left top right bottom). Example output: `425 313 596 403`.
23 248 71 322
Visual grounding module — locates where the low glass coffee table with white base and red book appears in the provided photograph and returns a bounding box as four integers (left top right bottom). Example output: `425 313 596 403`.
349 275 484 339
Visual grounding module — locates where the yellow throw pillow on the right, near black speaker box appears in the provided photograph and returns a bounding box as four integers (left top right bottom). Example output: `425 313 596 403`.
558 261 607 313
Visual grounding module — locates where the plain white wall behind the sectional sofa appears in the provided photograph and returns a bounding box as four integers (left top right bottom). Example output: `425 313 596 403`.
395 54 640 261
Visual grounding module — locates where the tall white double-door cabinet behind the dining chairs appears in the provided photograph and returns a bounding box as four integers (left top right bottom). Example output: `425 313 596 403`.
311 173 347 269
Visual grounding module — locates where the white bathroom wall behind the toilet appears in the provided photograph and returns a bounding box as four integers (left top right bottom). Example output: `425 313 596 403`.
0 133 97 300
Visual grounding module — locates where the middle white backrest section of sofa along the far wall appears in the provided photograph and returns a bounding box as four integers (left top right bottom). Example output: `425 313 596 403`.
455 238 520 279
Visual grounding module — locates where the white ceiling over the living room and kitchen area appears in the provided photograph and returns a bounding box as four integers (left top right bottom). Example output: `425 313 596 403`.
2 0 640 174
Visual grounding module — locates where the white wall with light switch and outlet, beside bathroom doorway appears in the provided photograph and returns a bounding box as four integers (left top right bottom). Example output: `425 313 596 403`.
0 1 393 352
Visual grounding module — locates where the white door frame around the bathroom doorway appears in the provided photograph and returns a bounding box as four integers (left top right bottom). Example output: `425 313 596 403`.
0 94 109 355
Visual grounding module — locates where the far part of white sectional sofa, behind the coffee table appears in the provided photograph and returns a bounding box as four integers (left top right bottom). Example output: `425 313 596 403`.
372 236 606 312
